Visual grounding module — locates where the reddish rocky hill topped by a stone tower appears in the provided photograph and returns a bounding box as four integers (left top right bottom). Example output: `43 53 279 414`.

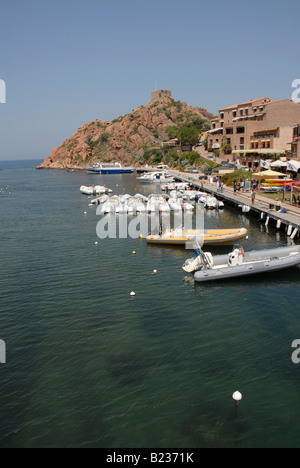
38 96 213 169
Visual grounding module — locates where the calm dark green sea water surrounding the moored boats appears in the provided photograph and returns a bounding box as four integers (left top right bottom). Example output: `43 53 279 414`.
0 162 300 448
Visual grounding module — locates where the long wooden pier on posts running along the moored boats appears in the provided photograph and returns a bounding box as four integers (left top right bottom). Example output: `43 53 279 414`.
170 171 300 239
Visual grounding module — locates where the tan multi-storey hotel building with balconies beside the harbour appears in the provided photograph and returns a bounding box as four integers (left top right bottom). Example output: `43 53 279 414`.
208 98 300 168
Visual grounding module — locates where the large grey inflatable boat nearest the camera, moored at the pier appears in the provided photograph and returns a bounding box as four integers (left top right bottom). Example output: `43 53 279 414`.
183 246 300 282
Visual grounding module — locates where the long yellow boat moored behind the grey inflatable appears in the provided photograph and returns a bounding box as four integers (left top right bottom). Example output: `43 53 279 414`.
146 228 248 245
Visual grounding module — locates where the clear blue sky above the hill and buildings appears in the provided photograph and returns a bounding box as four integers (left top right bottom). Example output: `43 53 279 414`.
0 0 300 160
